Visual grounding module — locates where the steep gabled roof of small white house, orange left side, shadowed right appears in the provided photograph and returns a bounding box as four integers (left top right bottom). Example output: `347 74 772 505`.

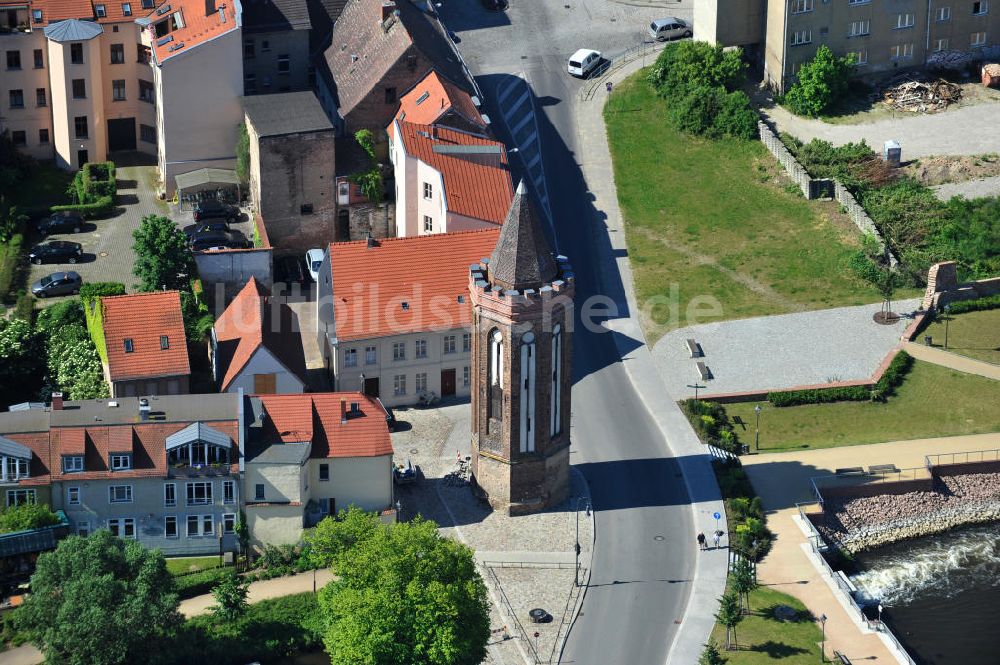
215 277 306 391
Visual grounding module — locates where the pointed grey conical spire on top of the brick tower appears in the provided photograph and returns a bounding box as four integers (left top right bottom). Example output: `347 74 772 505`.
489 180 559 290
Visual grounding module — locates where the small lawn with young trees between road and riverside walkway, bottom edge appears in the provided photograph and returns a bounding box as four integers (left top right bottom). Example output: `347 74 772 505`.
712 587 822 665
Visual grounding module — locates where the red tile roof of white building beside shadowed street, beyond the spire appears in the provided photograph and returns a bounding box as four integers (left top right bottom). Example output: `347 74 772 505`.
399 122 514 225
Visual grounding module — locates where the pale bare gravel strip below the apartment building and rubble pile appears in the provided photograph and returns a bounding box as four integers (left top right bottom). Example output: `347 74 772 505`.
762 102 1000 160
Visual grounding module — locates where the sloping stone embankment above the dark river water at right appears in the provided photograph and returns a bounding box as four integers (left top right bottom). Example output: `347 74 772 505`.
816 473 1000 553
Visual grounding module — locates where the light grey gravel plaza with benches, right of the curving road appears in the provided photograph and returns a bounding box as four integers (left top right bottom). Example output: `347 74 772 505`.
653 299 920 399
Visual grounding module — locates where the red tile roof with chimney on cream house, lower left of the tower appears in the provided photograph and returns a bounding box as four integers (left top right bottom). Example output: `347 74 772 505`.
257 392 392 459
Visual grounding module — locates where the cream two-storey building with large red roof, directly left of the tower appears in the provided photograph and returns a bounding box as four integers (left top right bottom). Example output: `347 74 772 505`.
316 227 500 406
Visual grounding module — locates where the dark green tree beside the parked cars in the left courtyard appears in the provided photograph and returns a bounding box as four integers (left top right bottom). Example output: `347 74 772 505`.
132 215 195 291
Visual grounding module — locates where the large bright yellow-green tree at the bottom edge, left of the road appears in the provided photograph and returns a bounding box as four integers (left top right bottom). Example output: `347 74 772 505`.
319 519 490 665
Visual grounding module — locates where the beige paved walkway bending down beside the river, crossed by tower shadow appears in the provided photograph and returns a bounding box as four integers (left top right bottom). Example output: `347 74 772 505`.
742 434 1000 663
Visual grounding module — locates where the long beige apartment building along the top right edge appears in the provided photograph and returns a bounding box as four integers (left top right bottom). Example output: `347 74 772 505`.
694 0 1000 90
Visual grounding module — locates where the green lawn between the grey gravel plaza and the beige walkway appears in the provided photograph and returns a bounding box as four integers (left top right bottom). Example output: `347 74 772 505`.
726 360 1000 452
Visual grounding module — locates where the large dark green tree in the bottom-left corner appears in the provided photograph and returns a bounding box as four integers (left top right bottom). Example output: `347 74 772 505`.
15 530 181 665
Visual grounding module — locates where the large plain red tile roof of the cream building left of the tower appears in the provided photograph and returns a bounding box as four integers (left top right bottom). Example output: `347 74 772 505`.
330 228 500 341
